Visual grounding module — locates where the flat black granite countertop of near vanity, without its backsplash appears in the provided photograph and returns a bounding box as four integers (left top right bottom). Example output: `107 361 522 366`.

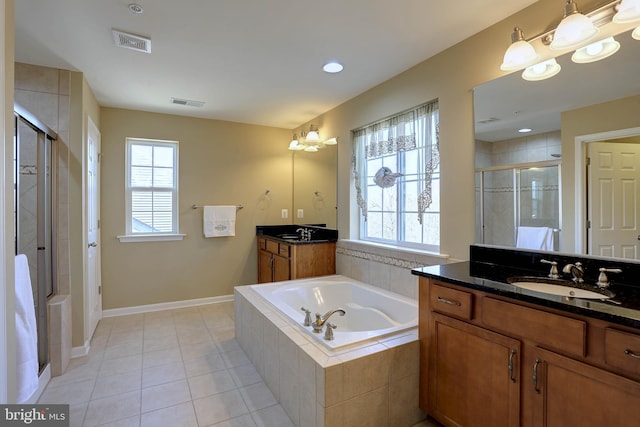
412 261 640 329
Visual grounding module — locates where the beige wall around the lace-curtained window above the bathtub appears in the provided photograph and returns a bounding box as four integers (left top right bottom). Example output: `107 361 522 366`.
314 0 580 259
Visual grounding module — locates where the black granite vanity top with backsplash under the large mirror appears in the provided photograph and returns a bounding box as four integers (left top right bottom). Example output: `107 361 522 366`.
412 245 640 329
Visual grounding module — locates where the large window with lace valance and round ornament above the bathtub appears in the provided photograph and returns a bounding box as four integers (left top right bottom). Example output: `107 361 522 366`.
352 101 440 251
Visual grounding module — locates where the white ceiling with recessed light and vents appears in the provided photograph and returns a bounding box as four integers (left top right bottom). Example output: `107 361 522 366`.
15 0 536 129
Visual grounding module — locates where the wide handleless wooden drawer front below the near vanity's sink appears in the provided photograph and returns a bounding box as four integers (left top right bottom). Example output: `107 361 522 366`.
481 297 587 357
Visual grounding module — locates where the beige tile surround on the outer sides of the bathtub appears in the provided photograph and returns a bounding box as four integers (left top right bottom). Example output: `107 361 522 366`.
235 286 425 427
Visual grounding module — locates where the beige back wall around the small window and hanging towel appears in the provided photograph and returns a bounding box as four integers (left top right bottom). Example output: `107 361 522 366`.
100 108 292 309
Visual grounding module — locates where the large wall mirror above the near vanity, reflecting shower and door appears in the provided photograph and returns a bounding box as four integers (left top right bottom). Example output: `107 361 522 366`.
474 32 640 259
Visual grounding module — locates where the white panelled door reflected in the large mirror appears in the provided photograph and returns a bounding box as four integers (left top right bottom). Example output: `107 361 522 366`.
587 142 640 259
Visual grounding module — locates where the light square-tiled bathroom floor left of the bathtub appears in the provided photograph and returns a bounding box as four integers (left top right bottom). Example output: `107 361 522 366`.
39 303 437 427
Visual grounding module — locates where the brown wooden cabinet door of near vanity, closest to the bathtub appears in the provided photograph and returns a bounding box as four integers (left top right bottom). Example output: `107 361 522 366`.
428 313 520 427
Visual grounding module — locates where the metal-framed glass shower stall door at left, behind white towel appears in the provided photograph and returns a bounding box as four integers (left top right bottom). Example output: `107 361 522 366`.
13 104 57 370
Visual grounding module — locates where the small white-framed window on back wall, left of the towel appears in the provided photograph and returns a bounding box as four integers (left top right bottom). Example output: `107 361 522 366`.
126 138 178 236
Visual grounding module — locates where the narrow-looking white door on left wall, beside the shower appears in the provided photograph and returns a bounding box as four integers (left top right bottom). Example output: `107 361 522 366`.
86 118 102 339
